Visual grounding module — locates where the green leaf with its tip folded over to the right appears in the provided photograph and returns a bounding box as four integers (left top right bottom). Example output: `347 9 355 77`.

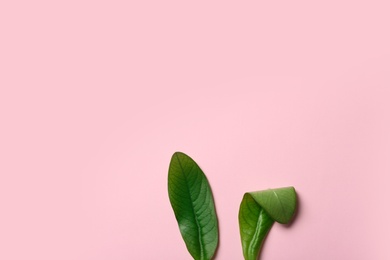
239 187 297 260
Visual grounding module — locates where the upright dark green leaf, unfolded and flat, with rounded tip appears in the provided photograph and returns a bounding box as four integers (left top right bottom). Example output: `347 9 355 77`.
168 152 218 260
